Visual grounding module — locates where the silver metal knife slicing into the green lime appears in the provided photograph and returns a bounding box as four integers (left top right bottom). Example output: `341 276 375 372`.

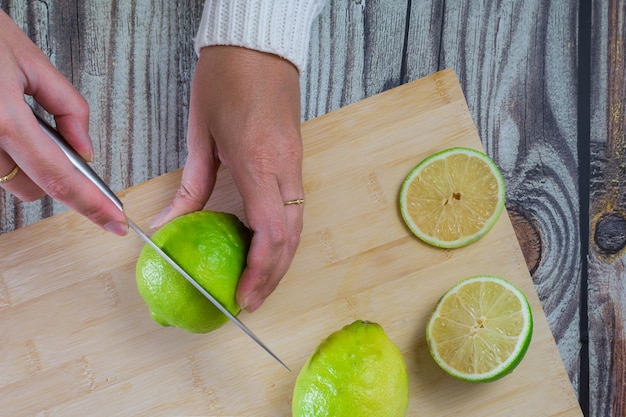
33 109 291 372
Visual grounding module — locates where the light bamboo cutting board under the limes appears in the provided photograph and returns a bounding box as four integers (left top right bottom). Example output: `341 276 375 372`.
0 70 582 416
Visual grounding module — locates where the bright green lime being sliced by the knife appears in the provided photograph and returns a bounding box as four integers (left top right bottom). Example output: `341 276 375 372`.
136 211 251 333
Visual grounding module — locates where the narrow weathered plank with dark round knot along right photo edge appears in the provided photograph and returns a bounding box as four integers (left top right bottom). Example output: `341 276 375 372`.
588 0 626 416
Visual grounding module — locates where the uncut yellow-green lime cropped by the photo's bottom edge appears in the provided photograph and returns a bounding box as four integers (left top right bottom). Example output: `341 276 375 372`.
292 320 409 417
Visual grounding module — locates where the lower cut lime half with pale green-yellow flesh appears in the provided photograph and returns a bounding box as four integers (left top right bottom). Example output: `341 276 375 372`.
426 276 533 382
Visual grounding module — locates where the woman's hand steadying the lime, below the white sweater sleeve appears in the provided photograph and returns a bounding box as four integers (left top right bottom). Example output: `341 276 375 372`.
153 46 304 311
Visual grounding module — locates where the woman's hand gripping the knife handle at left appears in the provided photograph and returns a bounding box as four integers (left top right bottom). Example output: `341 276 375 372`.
0 10 128 235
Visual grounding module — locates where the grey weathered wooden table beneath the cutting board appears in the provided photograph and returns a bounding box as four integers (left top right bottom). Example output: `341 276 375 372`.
0 0 626 416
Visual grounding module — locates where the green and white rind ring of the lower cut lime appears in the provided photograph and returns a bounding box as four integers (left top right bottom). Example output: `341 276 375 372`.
426 275 533 382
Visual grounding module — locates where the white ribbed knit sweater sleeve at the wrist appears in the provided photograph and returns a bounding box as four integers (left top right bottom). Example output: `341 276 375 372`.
195 0 326 73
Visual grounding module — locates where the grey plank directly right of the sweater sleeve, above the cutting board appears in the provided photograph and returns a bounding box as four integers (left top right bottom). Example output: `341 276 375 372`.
301 0 408 120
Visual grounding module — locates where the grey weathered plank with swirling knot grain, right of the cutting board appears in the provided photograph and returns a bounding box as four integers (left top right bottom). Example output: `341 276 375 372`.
407 0 581 387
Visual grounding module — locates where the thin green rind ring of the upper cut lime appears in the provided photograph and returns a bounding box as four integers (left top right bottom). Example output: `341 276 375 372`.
400 147 506 249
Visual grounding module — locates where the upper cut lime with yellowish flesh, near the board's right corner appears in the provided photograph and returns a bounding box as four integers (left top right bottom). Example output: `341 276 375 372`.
400 147 505 248
